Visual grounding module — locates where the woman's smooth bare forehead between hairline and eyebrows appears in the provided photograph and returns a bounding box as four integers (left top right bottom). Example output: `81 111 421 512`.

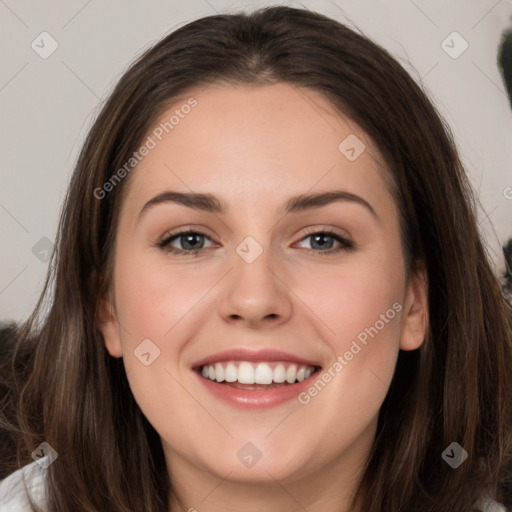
123 83 388 212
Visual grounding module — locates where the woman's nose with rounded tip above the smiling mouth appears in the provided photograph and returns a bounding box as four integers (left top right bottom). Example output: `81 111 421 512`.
219 243 293 329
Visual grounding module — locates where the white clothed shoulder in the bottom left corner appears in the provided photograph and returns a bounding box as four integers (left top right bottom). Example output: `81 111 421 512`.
0 462 46 512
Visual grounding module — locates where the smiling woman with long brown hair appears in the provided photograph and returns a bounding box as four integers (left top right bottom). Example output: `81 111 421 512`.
0 7 512 512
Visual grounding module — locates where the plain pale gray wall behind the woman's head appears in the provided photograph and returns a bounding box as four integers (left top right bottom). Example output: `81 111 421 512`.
0 0 512 320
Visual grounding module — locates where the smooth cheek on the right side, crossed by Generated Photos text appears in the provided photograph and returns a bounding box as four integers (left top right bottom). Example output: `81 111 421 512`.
294 249 405 424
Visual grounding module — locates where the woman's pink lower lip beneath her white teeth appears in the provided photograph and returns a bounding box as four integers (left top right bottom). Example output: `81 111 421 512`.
194 371 319 409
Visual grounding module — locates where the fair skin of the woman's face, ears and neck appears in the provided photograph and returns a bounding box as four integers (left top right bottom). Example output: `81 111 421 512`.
100 84 427 512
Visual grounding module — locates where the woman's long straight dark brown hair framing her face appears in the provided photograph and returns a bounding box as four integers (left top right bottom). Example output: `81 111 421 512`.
5 7 512 512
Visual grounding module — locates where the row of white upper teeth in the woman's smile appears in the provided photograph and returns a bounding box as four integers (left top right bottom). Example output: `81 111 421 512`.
201 361 315 385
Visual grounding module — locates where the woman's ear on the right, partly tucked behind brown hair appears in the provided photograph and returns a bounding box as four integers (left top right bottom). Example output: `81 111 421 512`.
400 268 428 350
